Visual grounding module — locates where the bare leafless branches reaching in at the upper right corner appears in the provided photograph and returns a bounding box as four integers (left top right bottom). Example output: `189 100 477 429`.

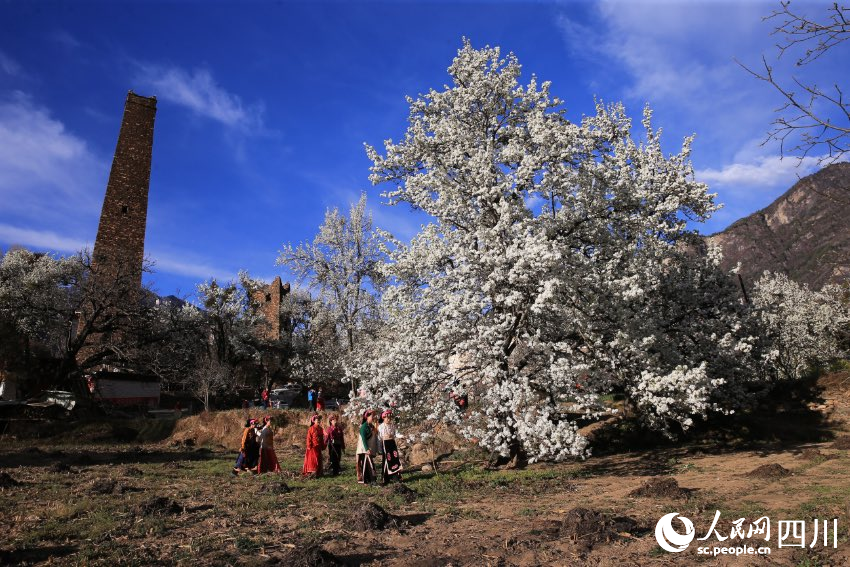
739 1 850 163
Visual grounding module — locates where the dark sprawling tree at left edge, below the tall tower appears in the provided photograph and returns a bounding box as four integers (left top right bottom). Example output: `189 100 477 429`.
0 246 177 394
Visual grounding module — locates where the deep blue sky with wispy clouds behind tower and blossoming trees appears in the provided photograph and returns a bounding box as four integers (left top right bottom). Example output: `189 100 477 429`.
0 1 850 294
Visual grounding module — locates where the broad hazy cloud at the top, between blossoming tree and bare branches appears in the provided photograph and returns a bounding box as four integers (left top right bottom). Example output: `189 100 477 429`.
556 0 777 155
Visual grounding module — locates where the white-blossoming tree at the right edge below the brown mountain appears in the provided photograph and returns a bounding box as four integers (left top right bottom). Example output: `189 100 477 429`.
753 272 850 379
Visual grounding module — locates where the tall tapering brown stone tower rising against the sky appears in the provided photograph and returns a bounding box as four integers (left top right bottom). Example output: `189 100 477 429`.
92 91 156 289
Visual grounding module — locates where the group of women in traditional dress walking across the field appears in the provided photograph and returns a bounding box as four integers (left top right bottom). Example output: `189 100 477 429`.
233 410 403 484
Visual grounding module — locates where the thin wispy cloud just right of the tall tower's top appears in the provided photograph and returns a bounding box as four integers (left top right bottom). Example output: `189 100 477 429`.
138 65 264 130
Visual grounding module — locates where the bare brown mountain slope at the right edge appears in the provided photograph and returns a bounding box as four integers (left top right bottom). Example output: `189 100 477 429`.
706 163 850 289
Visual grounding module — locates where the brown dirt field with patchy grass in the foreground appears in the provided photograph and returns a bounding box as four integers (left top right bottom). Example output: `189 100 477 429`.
0 374 850 567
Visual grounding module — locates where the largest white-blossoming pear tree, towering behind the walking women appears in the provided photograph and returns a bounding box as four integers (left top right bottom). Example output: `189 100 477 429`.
352 41 754 460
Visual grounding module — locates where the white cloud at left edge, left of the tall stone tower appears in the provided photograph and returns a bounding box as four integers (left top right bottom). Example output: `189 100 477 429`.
0 92 107 218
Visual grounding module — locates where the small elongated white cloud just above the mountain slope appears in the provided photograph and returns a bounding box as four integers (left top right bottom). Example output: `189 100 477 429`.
695 156 820 189
